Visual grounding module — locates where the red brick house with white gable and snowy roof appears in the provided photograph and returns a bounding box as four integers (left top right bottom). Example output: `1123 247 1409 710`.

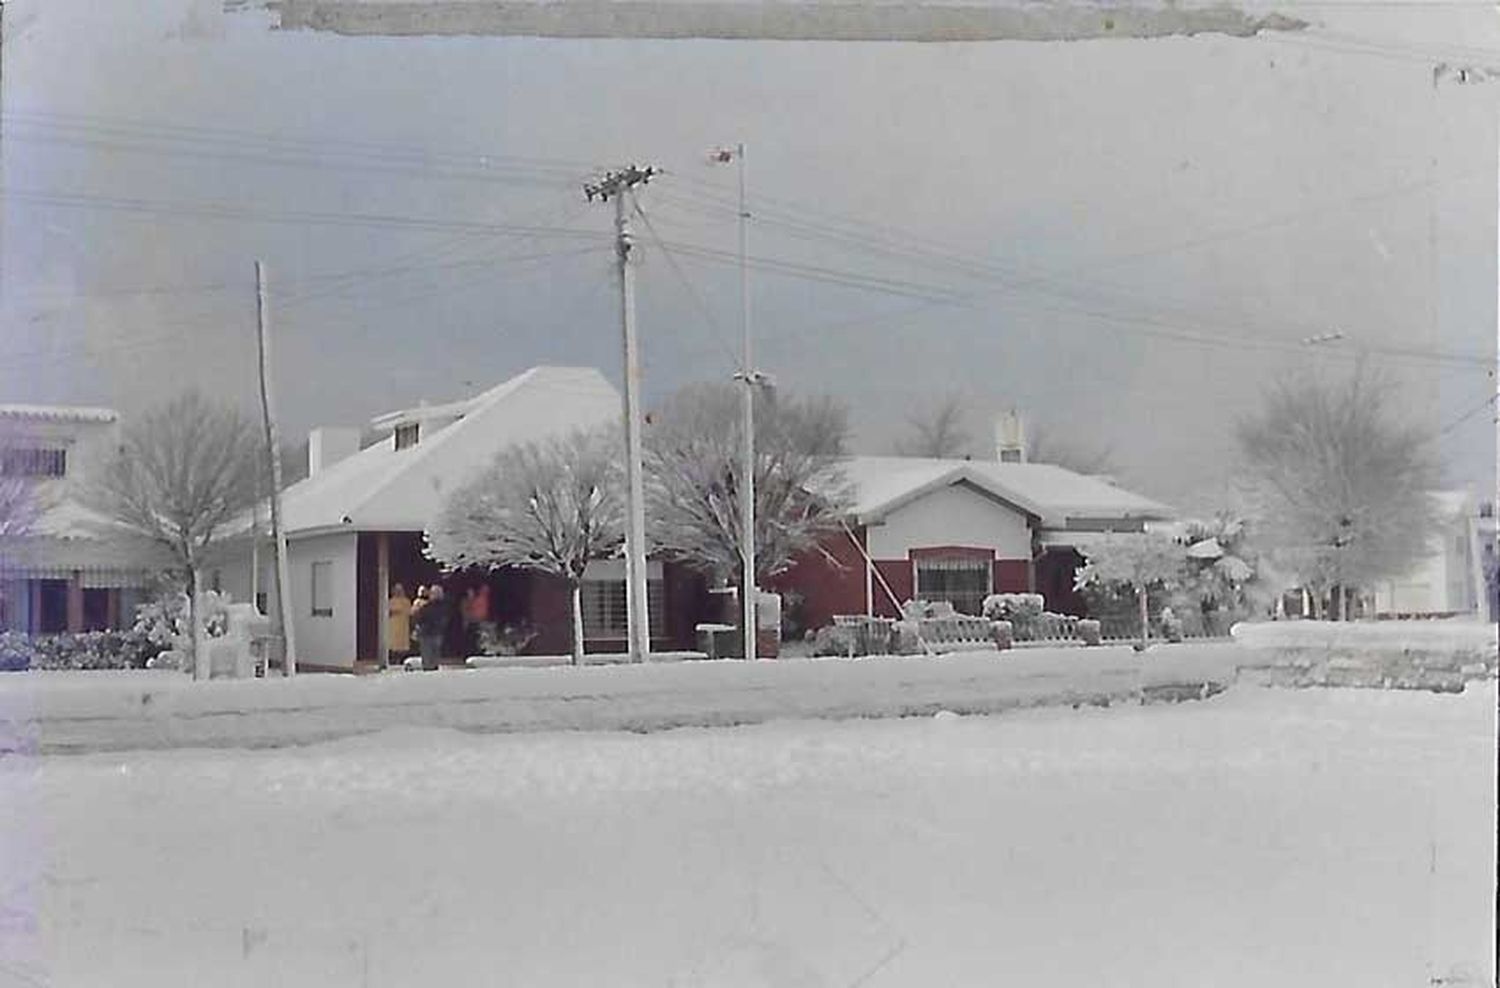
774 456 1172 628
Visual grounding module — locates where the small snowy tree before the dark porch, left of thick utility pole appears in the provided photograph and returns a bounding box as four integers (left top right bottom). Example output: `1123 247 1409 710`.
428 430 626 664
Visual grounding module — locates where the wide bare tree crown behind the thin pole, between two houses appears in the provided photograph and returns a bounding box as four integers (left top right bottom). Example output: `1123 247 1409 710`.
647 385 852 611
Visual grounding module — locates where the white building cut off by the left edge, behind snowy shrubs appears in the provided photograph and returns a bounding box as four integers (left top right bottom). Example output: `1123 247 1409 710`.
0 405 164 634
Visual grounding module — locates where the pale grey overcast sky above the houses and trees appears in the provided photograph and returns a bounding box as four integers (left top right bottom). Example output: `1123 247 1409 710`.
0 0 1500 507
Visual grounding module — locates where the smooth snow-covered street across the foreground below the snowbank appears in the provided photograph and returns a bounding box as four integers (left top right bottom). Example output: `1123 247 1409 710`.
0 681 1497 988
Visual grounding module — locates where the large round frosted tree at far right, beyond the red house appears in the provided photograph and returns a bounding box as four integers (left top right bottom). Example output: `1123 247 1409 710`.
1239 369 1437 618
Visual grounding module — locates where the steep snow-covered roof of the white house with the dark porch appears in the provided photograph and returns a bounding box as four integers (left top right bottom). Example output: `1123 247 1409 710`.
271 367 620 537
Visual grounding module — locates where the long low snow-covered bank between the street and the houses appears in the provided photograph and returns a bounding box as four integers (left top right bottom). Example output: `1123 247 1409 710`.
0 643 1241 753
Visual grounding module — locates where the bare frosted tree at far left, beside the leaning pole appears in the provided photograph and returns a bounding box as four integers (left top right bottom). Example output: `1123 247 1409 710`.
83 391 262 679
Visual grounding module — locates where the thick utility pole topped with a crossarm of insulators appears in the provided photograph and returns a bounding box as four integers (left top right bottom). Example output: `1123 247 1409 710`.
584 165 660 663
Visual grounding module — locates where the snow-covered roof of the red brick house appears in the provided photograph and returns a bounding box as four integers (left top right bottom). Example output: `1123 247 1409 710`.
845 456 1173 528
